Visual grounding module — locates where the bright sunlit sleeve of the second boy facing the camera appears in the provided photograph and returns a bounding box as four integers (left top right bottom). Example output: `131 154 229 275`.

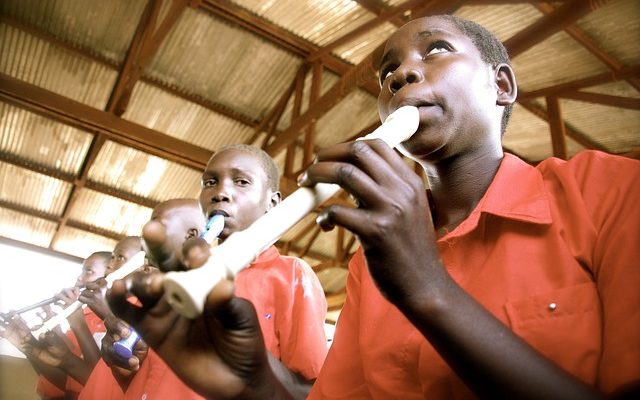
277 258 327 379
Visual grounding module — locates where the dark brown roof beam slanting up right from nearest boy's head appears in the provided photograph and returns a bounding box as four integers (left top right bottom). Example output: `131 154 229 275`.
504 0 607 58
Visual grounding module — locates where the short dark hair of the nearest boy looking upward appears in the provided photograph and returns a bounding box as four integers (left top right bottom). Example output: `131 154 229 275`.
435 14 513 135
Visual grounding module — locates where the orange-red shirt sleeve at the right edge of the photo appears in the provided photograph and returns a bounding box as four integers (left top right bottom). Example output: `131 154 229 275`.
574 152 640 393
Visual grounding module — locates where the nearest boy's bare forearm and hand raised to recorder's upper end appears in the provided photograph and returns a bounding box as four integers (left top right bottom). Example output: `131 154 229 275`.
304 141 599 399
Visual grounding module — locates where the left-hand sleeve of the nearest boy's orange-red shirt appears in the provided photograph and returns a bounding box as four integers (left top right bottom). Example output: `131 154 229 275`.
309 249 371 400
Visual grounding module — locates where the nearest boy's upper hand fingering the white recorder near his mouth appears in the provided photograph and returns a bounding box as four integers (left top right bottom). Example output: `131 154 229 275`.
301 140 444 305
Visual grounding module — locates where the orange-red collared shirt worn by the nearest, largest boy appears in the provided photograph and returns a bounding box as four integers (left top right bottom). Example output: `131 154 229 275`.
310 151 640 399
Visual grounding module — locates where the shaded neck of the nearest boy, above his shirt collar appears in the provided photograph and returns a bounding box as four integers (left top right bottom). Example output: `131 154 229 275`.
423 149 503 236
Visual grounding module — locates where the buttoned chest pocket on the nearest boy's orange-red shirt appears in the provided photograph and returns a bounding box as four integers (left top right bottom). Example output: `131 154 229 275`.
505 282 602 384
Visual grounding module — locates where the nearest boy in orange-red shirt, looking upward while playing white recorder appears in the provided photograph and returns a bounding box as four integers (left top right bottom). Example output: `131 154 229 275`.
111 16 640 399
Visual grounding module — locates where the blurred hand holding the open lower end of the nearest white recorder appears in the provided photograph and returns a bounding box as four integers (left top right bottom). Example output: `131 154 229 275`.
107 273 281 399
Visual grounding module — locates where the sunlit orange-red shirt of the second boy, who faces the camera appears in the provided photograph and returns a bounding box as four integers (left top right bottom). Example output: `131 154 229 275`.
235 246 327 379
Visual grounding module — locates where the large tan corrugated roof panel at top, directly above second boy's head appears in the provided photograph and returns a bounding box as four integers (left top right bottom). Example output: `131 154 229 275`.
146 9 300 120
